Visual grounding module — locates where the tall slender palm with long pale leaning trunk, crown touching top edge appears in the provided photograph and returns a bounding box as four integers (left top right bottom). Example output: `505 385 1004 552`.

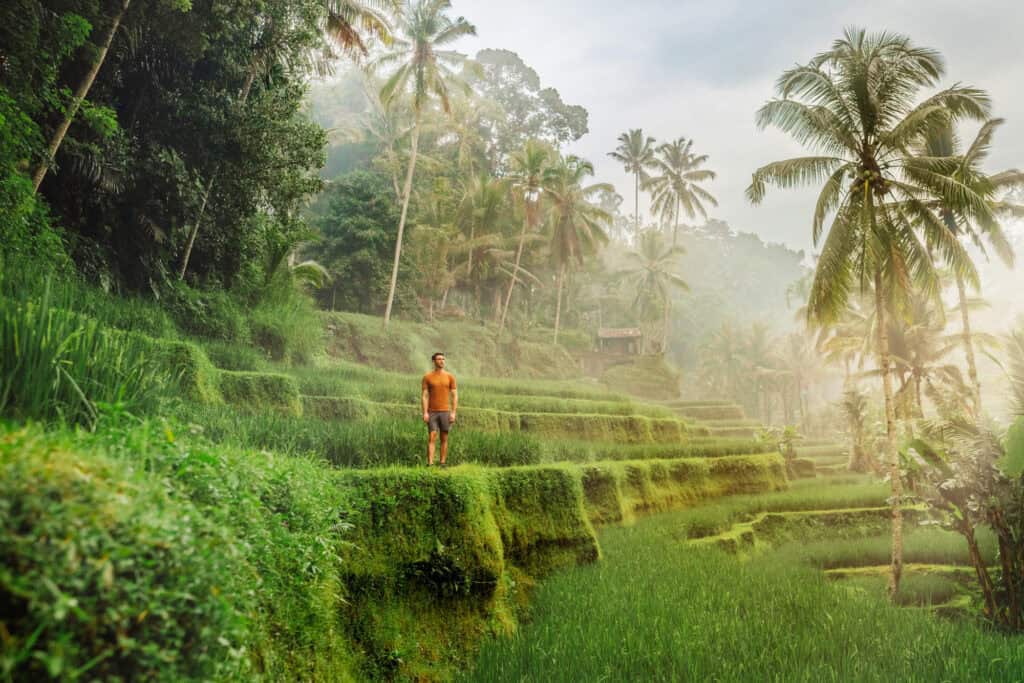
373 0 476 327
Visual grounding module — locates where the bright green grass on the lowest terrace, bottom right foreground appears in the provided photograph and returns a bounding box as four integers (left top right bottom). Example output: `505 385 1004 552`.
464 494 1024 682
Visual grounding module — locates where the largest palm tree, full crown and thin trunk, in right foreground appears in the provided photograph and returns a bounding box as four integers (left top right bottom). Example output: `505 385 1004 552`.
746 29 992 596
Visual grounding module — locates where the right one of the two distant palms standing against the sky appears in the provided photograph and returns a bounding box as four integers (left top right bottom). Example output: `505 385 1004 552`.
645 137 718 245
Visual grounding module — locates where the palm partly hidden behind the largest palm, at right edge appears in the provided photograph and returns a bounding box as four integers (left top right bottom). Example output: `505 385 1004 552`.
919 119 1024 415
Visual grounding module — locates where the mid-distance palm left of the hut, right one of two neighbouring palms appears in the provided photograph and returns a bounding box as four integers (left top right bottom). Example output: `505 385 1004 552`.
543 156 612 344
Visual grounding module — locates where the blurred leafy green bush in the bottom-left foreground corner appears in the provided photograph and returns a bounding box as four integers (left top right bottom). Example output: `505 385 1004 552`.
0 430 247 680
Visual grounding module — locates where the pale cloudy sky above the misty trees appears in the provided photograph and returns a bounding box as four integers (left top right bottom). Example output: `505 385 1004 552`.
452 0 1024 259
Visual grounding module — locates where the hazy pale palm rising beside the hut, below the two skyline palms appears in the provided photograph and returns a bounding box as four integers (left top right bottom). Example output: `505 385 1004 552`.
620 230 689 352
